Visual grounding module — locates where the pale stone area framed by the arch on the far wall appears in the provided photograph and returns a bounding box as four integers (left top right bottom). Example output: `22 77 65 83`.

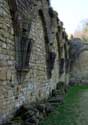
71 50 88 84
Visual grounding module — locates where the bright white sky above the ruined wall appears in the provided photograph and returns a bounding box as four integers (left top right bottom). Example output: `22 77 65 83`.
51 0 88 33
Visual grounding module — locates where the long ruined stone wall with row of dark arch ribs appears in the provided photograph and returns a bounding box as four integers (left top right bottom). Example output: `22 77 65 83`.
0 0 69 124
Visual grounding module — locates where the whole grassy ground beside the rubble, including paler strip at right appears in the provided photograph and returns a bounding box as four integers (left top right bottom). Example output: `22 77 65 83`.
40 86 88 125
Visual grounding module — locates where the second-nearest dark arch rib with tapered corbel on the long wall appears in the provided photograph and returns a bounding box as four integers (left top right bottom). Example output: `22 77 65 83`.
39 9 56 79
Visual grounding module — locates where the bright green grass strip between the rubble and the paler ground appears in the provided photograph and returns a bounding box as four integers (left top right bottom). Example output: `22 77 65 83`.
40 85 88 125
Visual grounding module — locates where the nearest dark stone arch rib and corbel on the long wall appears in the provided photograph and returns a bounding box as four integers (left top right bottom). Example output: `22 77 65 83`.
8 0 34 83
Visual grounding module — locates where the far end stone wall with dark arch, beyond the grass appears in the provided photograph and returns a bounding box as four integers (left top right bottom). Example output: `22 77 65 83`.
70 38 88 84
